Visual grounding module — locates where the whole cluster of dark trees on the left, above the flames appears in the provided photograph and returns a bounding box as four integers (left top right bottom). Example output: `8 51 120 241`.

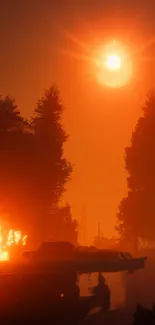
0 86 77 246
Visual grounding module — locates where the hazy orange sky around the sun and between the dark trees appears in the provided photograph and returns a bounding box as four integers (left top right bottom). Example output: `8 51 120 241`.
0 0 155 239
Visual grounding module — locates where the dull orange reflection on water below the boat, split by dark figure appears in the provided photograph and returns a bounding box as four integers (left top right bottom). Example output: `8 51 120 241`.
79 273 125 309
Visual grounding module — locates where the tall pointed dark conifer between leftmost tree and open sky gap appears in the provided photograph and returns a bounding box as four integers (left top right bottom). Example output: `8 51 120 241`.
32 86 72 237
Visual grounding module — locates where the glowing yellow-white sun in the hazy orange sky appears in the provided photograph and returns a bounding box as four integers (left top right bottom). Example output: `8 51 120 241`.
93 42 132 88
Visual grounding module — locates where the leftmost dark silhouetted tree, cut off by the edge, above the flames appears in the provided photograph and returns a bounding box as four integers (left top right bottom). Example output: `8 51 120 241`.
0 97 33 228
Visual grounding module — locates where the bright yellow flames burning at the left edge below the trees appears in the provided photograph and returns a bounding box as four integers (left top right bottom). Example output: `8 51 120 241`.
0 227 27 262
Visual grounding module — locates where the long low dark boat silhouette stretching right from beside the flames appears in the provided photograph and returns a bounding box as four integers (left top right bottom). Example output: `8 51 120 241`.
23 242 147 273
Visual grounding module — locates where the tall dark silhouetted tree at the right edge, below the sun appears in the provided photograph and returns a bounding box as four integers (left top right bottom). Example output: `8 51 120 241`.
117 92 155 243
